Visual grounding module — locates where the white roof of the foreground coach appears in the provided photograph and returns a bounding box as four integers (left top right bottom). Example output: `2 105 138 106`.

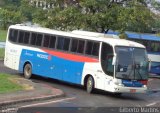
9 24 145 48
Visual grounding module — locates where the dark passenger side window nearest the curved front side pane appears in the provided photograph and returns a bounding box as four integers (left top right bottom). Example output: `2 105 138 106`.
85 41 99 56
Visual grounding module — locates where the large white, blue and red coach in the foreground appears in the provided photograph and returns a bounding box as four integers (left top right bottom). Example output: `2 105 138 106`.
4 24 148 94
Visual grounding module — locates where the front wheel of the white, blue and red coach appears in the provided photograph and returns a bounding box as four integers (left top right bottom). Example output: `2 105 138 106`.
86 76 94 93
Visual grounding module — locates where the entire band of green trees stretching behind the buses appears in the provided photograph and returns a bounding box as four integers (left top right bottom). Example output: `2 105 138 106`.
0 0 155 32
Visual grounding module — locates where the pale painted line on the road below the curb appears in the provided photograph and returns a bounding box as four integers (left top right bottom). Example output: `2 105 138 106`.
20 97 76 108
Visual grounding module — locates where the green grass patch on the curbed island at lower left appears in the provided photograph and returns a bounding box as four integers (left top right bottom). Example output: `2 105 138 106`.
0 73 23 93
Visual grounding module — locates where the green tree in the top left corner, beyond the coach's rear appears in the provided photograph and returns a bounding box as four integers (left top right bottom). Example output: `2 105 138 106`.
0 0 25 29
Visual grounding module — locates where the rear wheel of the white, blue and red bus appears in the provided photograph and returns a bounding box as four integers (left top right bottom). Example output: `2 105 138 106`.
24 64 32 79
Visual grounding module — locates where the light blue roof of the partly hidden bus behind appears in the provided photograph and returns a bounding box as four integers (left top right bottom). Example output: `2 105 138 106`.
108 31 160 41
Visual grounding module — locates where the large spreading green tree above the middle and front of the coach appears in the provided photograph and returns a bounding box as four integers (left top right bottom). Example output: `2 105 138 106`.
34 0 153 32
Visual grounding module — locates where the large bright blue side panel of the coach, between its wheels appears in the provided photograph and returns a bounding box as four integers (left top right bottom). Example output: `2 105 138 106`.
19 49 84 84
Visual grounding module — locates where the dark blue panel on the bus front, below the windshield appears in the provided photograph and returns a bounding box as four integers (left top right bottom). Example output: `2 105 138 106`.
122 80 143 87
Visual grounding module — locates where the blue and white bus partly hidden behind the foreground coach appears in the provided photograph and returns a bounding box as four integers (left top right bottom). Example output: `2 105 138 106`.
108 31 160 75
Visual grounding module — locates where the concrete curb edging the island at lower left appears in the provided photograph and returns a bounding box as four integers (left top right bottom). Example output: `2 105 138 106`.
0 89 65 107
